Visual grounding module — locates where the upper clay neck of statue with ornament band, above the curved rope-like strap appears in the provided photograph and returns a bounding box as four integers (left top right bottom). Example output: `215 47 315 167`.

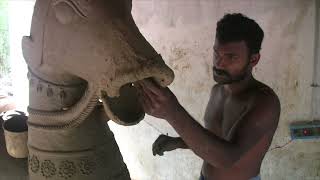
28 69 87 111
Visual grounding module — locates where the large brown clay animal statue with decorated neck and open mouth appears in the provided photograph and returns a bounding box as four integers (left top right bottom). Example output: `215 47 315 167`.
22 0 174 180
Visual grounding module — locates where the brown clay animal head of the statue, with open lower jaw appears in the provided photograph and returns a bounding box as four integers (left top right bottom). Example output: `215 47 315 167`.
22 0 174 124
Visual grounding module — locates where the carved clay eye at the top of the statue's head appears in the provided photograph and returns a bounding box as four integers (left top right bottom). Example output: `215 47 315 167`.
53 0 87 24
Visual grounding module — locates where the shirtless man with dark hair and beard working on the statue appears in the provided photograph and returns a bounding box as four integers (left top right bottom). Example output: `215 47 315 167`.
137 14 280 180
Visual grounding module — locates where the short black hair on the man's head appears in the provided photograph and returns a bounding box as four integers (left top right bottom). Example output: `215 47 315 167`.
216 13 264 54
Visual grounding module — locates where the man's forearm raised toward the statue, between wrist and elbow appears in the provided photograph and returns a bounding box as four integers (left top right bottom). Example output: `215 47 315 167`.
167 107 237 167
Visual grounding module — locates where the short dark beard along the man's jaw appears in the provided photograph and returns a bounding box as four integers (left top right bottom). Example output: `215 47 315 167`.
213 64 249 84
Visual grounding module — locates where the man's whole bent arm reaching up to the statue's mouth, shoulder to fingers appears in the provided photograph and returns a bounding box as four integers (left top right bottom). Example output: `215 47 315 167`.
140 81 280 168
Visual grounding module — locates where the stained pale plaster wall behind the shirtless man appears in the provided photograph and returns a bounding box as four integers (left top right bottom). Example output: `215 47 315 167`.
109 0 320 180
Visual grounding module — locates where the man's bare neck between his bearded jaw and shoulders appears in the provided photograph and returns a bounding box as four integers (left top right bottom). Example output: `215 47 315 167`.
223 73 255 95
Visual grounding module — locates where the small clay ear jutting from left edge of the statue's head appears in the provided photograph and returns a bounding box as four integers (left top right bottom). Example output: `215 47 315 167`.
22 36 42 68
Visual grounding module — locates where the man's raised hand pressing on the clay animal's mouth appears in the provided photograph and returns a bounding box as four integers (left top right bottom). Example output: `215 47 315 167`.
135 79 182 119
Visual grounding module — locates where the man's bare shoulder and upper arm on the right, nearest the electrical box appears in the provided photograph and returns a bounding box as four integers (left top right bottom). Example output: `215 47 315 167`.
236 82 280 151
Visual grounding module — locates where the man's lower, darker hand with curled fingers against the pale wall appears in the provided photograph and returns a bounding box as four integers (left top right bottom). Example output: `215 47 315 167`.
152 134 187 156
